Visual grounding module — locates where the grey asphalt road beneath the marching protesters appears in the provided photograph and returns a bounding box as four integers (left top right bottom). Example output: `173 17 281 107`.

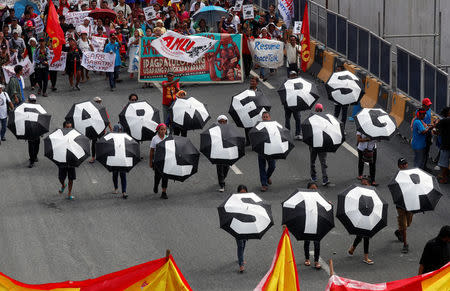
0 68 450 290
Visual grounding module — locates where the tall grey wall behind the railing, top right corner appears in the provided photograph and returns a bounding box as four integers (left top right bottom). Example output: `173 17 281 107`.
314 0 450 65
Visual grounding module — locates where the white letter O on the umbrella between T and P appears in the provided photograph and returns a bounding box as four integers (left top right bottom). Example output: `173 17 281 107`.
345 187 383 230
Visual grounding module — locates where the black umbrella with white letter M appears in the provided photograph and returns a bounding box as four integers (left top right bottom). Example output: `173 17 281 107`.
169 97 211 130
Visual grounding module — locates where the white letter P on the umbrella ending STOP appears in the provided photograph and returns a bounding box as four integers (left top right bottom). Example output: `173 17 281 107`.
395 169 433 211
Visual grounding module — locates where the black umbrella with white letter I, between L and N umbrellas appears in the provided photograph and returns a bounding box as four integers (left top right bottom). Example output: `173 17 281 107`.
248 121 295 159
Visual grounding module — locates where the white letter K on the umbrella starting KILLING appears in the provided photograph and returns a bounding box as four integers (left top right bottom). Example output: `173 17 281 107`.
48 129 84 163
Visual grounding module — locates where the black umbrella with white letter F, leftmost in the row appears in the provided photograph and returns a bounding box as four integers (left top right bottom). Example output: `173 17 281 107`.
8 103 51 140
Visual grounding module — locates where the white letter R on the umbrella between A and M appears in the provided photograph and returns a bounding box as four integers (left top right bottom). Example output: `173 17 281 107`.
125 102 158 140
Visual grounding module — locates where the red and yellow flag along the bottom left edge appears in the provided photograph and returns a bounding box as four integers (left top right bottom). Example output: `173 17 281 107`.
0 255 192 291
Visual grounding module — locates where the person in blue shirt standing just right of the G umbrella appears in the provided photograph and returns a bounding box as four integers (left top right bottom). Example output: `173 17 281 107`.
411 108 432 169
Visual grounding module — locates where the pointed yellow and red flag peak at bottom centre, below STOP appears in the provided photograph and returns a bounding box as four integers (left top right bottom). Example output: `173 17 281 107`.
255 227 300 291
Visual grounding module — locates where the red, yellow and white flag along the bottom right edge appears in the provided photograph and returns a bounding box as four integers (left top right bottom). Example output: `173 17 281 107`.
327 263 450 291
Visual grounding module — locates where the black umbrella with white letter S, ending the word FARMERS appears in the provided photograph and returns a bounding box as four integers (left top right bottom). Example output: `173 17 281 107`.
325 71 364 105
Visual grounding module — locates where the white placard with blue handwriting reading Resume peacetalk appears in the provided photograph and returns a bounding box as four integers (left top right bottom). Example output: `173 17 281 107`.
249 38 284 69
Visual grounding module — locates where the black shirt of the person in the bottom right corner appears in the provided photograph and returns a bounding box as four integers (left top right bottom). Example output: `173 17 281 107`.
420 238 450 274
